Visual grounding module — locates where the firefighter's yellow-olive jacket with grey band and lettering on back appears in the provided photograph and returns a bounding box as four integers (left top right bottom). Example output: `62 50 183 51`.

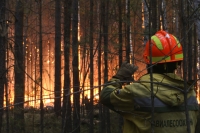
100 73 198 133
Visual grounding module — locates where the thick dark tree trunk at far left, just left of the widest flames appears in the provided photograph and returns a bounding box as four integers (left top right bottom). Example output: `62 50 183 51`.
14 0 25 133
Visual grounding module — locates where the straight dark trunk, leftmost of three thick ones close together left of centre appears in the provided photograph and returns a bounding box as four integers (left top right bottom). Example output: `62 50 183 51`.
54 0 61 116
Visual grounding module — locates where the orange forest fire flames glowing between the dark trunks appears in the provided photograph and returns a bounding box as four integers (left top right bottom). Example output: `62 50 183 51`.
1 0 200 111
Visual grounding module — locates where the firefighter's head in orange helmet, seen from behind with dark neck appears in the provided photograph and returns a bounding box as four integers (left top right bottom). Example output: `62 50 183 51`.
143 30 183 73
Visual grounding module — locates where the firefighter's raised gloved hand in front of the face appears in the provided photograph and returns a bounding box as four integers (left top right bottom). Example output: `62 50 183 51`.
113 61 138 80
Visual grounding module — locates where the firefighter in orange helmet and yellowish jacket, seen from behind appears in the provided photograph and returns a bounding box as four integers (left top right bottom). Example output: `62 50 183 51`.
100 30 198 133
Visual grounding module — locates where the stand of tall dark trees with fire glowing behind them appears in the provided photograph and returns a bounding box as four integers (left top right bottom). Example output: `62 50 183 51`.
0 0 200 133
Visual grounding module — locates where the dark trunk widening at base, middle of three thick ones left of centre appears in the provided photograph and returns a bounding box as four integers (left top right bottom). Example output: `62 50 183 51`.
62 0 72 133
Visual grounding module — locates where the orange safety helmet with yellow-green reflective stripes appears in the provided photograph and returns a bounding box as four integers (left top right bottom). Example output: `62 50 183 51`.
143 30 183 64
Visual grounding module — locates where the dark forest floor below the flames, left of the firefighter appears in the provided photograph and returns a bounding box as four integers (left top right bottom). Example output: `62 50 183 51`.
2 109 119 133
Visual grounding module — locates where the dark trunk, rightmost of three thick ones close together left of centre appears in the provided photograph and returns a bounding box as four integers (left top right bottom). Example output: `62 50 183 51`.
72 0 80 133
